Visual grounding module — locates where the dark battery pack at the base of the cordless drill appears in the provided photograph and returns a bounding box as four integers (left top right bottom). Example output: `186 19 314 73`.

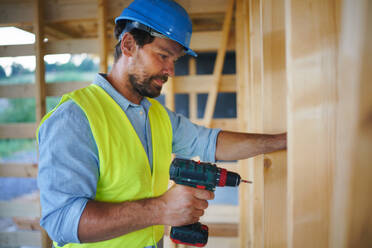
170 222 208 247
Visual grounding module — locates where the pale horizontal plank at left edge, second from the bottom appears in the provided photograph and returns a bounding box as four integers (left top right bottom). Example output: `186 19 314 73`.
0 201 40 218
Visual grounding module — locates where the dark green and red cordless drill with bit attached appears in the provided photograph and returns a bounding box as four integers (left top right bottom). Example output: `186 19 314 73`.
169 158 252 247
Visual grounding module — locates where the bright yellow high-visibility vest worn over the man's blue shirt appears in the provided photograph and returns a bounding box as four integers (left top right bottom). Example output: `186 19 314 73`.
37 84 172 248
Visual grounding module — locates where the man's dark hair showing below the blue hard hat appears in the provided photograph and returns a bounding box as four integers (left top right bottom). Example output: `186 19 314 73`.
114 21 154 62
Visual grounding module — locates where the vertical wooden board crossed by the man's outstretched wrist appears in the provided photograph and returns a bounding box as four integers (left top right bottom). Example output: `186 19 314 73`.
261 0 287 248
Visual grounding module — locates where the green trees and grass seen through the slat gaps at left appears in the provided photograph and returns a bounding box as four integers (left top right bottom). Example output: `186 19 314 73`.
0 57 98 157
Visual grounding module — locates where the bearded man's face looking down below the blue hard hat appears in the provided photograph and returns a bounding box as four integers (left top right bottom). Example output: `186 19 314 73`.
129 38 183 98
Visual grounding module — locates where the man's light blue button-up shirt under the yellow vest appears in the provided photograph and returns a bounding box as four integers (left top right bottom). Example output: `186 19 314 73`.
38 74 220 246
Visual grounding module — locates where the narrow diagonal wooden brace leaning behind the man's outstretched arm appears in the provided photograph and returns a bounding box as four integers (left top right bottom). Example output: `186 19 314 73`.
203 0 234 127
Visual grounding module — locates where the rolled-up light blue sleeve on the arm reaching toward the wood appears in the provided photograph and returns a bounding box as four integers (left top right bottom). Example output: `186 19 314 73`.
166 108 221 162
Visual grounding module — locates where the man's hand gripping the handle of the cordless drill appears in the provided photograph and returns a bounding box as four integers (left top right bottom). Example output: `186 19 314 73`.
158 184 214 226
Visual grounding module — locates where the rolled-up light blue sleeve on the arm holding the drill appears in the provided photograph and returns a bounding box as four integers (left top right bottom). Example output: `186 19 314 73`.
38 101 99 246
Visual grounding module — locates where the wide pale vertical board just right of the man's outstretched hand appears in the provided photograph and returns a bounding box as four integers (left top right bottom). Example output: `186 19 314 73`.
285 0 340 248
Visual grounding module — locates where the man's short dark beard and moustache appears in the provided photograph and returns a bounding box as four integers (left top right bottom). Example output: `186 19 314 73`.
129 74 168 98
